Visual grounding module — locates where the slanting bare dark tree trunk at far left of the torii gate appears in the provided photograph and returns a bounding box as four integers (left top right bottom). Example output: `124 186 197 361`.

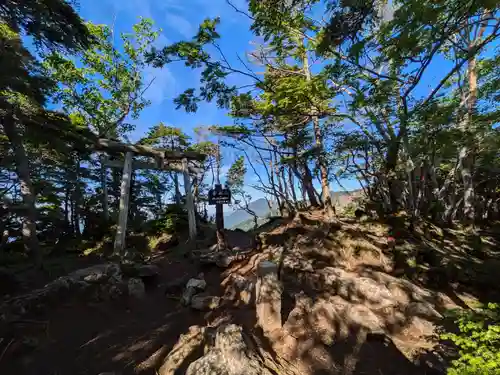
3 118 42 267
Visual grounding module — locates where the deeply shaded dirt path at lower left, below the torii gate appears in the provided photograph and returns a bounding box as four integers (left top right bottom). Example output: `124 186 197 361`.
0 260 219 375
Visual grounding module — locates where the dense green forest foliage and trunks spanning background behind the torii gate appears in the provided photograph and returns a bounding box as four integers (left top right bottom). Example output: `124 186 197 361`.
0 0 500 270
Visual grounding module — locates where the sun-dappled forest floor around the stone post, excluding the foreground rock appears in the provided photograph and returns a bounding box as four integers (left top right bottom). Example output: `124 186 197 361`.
0 212 500 375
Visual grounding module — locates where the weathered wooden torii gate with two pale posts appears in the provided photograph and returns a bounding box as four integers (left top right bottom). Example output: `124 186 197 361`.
95 138 205 254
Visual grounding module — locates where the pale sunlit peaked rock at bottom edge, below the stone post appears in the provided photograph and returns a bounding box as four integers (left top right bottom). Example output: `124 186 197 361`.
186 324 271 375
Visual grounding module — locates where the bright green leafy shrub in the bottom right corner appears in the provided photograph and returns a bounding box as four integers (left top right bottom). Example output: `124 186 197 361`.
441 303 500 375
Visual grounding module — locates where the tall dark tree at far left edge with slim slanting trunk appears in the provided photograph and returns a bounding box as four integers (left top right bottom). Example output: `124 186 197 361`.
0 1 92 266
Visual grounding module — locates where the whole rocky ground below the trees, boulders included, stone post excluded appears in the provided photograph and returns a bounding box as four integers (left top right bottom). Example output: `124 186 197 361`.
0 212 496 375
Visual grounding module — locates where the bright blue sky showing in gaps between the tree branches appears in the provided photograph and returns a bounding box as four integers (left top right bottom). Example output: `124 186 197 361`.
72 0 497 206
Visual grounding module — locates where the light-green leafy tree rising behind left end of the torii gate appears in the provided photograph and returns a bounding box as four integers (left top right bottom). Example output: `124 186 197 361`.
45 19 159 220
